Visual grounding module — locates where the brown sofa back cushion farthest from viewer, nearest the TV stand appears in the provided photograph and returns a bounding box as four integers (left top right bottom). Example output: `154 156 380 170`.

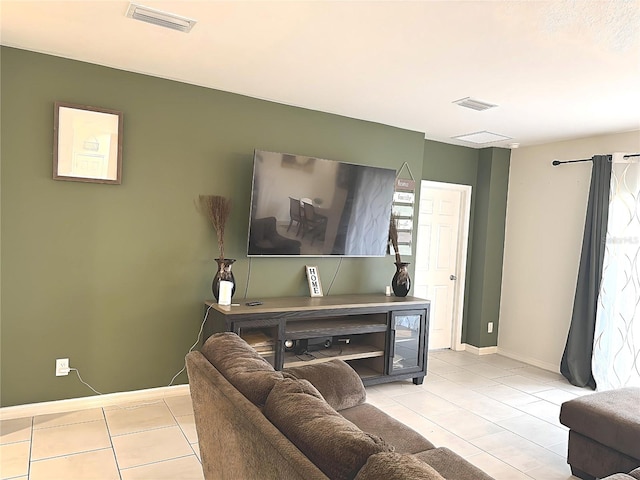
201 332 284 406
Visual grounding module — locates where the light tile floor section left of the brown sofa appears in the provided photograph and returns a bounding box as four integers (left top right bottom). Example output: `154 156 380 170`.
0 395 204 480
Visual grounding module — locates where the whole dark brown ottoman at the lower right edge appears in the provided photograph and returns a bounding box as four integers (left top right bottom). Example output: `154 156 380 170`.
560 387 640 480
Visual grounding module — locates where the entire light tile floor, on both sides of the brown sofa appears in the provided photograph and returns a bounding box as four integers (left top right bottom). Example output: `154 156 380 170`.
0 350 592 480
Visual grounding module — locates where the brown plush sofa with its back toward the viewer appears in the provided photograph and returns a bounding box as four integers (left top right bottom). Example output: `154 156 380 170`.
186 332 491 480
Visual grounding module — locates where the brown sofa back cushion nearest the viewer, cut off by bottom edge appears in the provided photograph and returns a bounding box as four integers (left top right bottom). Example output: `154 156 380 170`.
355 452 445 480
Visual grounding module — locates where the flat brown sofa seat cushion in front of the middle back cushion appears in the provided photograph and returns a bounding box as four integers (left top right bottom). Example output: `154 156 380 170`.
340 403 434 453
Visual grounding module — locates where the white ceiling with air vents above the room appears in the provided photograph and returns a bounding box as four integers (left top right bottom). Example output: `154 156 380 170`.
0 0 640 147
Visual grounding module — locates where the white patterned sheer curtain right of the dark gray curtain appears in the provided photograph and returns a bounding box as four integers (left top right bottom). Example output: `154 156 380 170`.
592 153 640 390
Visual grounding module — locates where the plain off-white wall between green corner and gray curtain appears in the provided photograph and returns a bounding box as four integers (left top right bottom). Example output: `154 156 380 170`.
498 130 640 372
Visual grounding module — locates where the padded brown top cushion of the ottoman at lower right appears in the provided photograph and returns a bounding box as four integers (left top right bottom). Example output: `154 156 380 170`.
560 387 640 459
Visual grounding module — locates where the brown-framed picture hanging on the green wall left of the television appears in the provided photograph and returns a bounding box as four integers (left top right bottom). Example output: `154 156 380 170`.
53 102 123 185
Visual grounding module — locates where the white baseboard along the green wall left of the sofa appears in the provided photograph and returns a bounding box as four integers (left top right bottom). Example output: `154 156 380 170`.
0 384 190 420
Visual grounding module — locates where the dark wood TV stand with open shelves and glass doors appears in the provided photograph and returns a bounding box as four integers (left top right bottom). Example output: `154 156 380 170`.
204 294 430 385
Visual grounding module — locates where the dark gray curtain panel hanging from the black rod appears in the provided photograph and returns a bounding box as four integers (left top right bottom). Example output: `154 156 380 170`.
560 155 611 390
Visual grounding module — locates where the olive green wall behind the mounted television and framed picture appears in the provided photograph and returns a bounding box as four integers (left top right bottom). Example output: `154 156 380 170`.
0 47 506 406
